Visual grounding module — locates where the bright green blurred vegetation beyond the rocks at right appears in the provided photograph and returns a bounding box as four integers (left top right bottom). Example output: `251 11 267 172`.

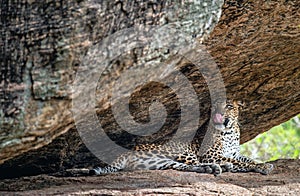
241 114 300 161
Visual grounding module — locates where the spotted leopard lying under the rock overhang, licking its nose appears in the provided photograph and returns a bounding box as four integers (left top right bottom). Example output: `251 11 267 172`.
89 100 273 176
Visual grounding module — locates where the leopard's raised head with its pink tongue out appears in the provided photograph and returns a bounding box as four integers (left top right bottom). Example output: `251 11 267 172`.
212 100 243 129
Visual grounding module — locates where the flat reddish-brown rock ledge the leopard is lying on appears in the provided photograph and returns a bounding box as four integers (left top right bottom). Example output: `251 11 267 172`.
0 159 300 195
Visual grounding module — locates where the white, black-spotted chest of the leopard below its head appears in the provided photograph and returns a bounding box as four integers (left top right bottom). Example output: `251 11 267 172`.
221 129 240 158
